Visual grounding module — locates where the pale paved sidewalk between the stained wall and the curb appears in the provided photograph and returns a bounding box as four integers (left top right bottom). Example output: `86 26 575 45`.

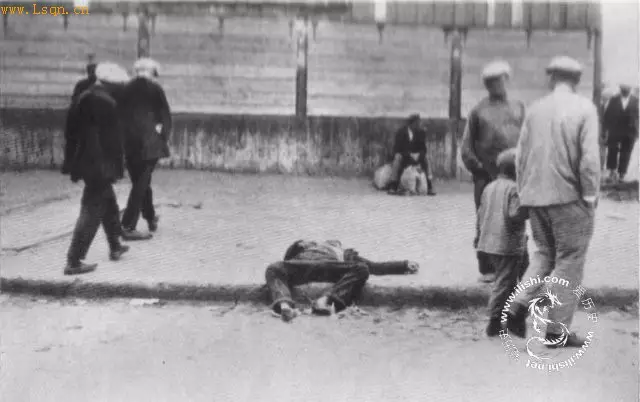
1 170 638 289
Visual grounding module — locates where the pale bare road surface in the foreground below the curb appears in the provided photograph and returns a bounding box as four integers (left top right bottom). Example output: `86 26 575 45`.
0 296 638 402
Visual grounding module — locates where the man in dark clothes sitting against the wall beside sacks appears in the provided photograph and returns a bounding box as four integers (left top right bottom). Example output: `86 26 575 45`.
388 114 436 196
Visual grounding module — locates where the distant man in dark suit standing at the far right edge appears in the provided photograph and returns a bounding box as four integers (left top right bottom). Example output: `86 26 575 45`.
603 85 638 181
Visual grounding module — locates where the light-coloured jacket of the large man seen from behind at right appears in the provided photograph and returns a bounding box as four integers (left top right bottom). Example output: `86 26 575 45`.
517 86 600 206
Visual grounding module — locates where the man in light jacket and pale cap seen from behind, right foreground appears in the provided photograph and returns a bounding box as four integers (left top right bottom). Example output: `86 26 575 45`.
507 57 601 347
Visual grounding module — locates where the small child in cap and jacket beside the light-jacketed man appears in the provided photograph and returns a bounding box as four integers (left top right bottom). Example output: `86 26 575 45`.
477 148 528 336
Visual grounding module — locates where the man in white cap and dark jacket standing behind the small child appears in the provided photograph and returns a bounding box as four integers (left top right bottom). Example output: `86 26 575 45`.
461 60 525 282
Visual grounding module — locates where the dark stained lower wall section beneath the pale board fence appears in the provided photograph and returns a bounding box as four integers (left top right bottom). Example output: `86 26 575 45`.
0 109 460 178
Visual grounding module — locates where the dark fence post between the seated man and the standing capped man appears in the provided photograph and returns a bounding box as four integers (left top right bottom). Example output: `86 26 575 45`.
449 29 462 176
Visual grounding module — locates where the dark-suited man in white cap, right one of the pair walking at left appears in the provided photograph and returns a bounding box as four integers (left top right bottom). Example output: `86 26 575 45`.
121 58 171 240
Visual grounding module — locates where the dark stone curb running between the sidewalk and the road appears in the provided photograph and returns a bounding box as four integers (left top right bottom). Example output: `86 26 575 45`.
0 278 638 311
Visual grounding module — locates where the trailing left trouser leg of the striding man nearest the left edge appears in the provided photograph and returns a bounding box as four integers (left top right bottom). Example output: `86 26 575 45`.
67 184 104 264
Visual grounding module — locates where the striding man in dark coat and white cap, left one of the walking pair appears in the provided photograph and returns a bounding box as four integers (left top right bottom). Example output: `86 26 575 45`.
62 63 129 275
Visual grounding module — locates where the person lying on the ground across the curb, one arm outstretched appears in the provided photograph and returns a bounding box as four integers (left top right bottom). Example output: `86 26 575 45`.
265 240 418 322
